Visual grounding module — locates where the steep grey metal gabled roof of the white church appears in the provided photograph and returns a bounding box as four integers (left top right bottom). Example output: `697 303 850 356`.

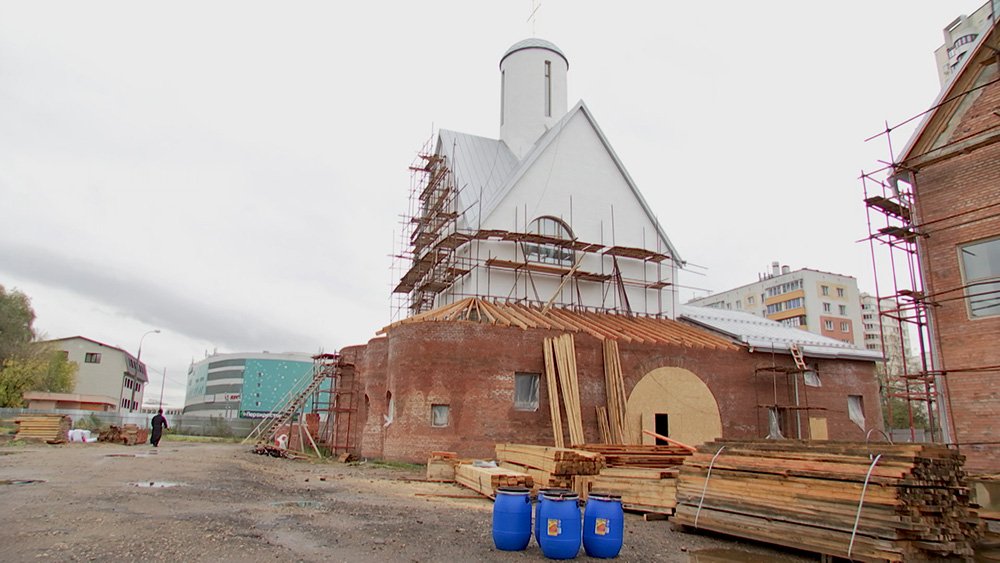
438 100 683 264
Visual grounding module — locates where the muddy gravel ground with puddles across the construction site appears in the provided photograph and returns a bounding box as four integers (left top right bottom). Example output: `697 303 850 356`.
0 441 816 562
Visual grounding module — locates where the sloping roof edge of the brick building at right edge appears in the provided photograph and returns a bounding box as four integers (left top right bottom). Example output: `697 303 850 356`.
896 17 1000 168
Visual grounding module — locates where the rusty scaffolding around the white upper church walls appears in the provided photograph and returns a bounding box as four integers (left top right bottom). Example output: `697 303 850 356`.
391 137 673 322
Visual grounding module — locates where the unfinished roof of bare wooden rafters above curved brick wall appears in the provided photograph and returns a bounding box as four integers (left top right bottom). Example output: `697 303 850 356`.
378 297 738 350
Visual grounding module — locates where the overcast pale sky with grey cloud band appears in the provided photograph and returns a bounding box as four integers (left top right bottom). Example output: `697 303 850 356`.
0 0 983 406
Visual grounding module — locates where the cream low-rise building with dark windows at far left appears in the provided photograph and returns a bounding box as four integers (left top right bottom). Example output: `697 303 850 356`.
47 336 149 413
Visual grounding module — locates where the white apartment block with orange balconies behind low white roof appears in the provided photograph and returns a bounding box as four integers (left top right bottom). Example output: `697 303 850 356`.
688 262 864 346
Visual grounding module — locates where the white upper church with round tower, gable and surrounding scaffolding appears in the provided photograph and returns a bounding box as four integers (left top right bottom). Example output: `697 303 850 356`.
394 39 682 318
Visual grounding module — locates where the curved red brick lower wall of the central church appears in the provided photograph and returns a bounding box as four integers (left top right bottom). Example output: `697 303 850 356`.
342 322 882 462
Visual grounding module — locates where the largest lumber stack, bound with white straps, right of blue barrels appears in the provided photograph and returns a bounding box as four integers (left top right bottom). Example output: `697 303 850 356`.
674 440 982 561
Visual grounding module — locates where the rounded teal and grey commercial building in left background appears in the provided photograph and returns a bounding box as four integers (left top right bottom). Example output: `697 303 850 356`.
184 352 313 418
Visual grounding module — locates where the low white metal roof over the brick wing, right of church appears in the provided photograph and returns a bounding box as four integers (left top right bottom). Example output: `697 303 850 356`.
679 305 882 361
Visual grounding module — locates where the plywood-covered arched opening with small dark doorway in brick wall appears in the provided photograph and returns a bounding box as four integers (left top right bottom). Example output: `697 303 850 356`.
627 367 722 446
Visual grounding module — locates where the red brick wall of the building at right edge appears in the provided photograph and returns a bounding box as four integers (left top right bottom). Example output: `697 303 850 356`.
916 75 1000 472
